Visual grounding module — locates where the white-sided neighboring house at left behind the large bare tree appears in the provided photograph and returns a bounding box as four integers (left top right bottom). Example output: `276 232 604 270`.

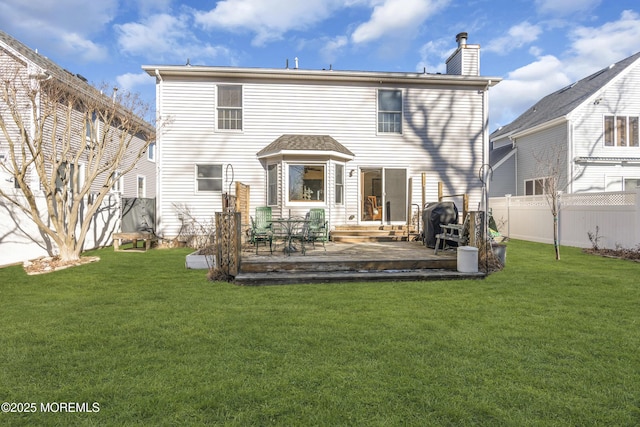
0 31 156 265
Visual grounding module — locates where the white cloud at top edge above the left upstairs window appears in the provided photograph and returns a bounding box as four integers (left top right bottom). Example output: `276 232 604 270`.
195 0 345 46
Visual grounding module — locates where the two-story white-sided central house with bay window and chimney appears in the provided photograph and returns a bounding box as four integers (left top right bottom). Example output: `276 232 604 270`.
142 33 500 238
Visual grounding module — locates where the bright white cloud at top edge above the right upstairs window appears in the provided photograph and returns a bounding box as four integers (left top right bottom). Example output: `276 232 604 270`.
351 0 449 43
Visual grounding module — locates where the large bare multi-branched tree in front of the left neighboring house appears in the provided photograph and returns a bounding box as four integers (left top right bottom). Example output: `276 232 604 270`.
0 66 155 261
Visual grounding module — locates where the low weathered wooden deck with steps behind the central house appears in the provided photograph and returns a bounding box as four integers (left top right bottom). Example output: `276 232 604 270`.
235 241 485 285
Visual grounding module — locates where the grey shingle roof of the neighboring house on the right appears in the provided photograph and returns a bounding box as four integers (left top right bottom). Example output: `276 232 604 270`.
491 52 640 139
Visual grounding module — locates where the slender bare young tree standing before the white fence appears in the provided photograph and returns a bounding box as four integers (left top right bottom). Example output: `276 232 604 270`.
533 144 568 260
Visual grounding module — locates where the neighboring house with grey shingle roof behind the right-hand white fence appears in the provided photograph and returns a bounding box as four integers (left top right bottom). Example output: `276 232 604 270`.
489 52 640 197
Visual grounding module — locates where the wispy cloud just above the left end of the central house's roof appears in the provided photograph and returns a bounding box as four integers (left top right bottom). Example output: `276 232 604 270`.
115 14 230 64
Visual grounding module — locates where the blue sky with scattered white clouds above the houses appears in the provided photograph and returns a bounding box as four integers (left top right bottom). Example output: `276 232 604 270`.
0 0 640 131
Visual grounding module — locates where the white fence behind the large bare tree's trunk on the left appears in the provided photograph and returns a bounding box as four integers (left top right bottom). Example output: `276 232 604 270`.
0 194 121 266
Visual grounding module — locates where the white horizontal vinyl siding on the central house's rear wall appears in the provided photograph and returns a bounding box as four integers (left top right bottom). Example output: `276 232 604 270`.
152 76 484 235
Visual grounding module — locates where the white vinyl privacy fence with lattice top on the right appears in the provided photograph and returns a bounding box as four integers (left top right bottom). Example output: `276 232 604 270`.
489 188 640 249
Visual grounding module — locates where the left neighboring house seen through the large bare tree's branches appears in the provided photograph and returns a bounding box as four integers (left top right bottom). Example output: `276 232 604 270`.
0 31 156 265
